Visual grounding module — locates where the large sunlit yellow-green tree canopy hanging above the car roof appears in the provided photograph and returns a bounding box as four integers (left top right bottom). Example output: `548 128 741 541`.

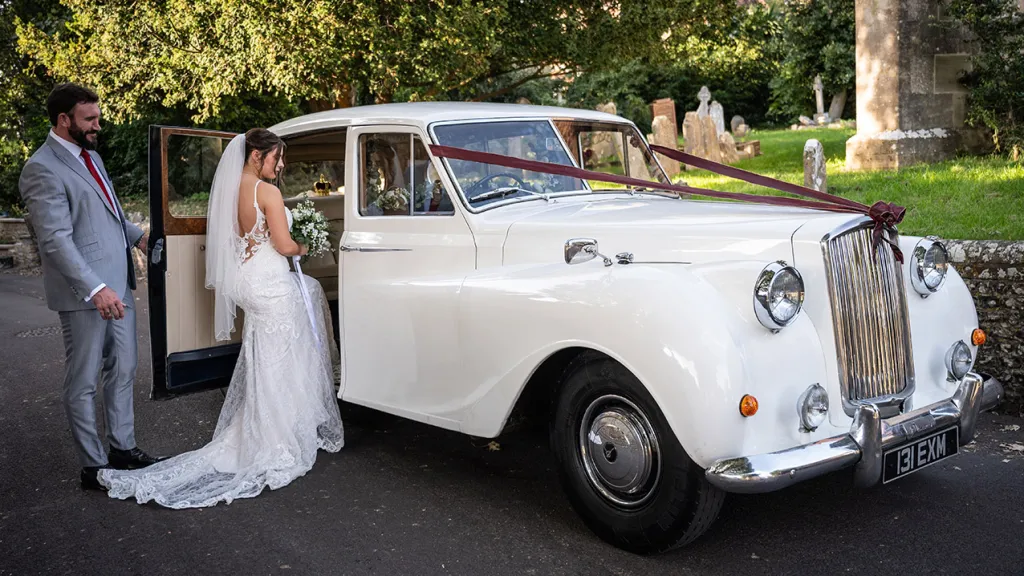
18 0 720 122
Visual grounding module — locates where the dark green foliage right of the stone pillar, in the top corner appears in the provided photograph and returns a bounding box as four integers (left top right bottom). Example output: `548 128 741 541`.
947 0 1024 161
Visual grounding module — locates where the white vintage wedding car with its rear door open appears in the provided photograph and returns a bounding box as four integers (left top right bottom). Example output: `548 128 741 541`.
148 102 1002 552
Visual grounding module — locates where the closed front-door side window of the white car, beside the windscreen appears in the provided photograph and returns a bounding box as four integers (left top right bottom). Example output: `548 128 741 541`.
359 133 454 216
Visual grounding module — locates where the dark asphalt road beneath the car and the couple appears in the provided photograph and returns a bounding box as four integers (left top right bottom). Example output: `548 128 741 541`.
0 274 1024 576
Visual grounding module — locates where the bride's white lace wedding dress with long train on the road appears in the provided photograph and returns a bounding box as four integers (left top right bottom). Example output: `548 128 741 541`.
98 182 344 508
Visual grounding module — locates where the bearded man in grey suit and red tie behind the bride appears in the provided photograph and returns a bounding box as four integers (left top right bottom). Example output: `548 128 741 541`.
18 84 160 490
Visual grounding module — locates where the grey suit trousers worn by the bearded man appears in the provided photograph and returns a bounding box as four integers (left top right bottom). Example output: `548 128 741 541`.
59 290 138 466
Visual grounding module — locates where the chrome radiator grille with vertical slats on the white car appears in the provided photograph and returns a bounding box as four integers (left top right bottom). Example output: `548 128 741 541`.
822 220 913 403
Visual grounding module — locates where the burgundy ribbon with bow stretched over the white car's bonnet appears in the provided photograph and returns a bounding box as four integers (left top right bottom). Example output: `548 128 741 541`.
430 145 905 263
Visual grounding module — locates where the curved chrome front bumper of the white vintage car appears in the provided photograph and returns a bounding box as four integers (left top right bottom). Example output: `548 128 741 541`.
705 372 1002 494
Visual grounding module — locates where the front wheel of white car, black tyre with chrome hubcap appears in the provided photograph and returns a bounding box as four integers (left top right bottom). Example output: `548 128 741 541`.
551 355 725 553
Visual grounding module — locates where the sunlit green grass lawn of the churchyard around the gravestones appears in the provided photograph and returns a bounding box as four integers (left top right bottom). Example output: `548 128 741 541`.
677 128 1024 240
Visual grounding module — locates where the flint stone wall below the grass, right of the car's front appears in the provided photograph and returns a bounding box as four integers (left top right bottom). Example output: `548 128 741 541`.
943 240 1024 415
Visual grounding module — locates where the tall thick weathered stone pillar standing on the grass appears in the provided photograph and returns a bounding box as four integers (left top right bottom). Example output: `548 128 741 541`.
846 0 990 170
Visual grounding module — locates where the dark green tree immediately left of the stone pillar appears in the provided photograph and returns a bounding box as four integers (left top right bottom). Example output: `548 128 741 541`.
769 0 856 123
